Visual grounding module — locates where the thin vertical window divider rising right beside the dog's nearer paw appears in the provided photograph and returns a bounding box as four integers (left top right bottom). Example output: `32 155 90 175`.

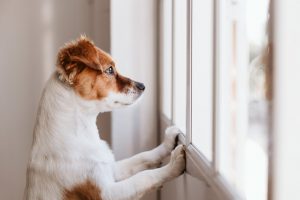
186 0 193 146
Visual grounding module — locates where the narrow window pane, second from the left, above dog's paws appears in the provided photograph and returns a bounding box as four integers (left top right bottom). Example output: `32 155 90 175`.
173 0 187 133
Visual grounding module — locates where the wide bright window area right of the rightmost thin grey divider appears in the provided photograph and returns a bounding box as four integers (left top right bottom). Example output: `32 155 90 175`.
217 0 269 200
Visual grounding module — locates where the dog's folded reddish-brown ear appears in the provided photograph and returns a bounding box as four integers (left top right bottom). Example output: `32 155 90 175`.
56 36 102 85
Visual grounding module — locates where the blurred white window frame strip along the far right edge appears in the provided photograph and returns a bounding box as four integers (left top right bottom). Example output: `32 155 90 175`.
270 0 300 200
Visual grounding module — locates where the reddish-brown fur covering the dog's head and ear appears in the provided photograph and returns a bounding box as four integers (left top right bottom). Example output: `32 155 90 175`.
57 37 134 100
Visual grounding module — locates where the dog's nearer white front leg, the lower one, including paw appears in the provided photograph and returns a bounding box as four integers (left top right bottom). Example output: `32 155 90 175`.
101 145 185 200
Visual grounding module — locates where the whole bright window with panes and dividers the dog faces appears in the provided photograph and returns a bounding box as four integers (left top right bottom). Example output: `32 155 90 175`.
160 0 271 200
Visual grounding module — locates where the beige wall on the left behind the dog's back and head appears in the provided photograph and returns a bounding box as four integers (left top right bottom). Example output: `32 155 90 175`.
0 0 110 200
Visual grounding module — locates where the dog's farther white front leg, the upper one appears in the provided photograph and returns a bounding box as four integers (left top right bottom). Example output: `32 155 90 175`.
114 127 180 181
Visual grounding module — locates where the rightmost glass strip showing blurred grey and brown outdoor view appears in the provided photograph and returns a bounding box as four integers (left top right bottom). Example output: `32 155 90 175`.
243 0 271 200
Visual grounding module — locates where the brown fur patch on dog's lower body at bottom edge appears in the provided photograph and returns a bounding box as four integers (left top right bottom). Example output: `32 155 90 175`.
64 180 102 200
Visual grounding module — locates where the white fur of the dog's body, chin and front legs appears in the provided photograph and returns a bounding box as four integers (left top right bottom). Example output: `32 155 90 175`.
25 74 185 200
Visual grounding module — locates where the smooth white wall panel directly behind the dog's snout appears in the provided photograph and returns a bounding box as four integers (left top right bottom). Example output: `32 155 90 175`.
111 0 158 199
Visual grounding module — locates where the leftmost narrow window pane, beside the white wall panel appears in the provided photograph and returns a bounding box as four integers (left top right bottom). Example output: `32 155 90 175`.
160 0 172 119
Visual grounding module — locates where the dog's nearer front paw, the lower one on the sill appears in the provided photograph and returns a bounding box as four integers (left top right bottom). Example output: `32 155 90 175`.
168 145 185 177
